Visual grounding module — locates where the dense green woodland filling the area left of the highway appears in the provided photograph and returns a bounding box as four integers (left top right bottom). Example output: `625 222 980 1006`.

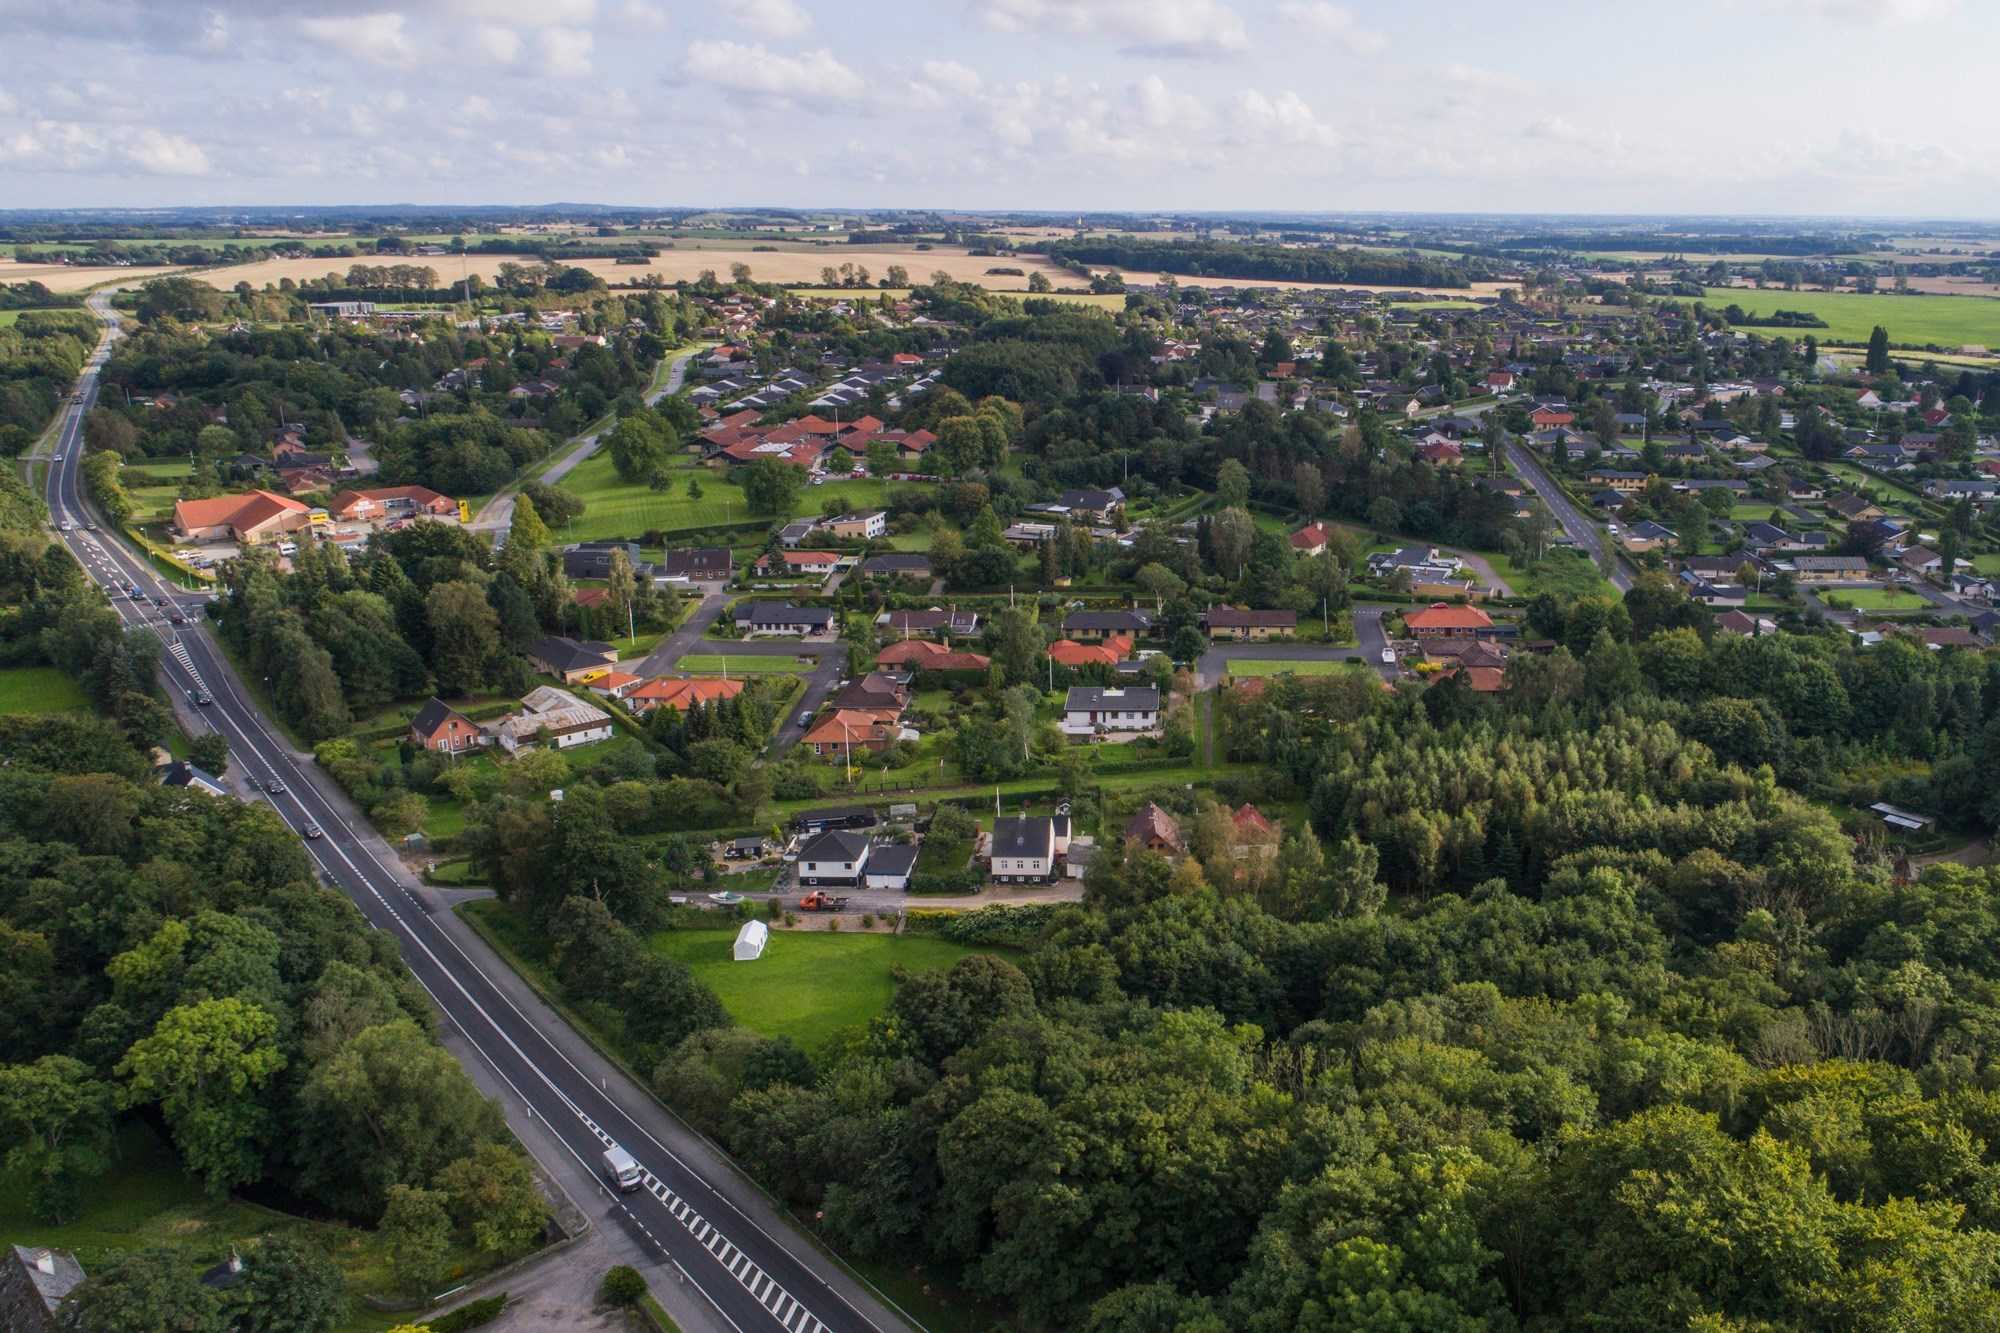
0 472 546 1331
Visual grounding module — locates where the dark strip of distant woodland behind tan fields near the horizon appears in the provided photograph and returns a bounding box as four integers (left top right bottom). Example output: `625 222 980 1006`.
1028 236 1484 286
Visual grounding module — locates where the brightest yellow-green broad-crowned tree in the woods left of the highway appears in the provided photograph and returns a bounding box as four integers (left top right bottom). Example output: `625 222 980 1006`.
118 997 286 1199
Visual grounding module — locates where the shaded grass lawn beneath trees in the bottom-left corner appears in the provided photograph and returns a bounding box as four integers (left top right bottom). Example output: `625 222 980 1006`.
0 1121 458 1333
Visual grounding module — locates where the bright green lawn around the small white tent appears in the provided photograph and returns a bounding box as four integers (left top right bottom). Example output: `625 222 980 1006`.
652 929 980 1051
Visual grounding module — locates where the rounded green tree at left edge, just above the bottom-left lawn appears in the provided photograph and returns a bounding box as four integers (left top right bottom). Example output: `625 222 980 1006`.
0 1055 112 1223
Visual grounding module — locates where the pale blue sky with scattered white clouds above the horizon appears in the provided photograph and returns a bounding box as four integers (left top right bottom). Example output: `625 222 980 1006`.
0 0 2000 220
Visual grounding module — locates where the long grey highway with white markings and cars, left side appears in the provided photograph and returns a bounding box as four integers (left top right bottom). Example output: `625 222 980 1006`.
46 292 912 1333
